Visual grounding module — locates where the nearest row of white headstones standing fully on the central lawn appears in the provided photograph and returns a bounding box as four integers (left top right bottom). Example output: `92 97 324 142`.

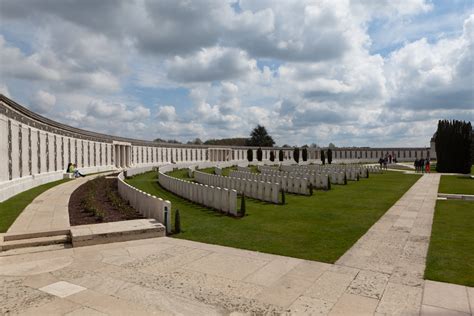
158 172 237 216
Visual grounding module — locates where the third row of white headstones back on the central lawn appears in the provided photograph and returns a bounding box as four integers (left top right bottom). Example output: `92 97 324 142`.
229 170 310 195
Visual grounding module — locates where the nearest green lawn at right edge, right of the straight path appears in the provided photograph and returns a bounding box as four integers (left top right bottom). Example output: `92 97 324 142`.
425 200 474 286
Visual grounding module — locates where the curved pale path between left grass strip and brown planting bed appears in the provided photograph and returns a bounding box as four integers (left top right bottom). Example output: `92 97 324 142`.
7 174 111 234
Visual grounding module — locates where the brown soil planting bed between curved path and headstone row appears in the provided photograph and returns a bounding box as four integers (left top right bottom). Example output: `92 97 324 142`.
69 177 143 226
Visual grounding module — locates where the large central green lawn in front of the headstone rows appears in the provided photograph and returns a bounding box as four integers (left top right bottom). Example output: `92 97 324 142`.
127 172 419 263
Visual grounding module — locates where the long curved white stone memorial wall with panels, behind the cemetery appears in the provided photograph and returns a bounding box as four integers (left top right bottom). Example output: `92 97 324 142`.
0 94 434 202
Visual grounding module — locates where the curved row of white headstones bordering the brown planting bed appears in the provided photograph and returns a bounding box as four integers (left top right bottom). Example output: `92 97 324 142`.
117 168 171 233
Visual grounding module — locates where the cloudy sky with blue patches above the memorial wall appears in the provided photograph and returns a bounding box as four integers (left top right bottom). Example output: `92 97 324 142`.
0 0 474 146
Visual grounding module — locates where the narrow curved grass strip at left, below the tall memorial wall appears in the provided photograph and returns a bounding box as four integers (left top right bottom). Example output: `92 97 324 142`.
0 179 70 233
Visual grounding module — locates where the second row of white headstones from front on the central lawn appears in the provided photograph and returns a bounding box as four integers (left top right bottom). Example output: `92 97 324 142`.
194 171 281 204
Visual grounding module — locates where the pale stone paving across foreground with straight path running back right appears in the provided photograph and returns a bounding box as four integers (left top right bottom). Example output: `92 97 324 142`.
0 175 474 315
